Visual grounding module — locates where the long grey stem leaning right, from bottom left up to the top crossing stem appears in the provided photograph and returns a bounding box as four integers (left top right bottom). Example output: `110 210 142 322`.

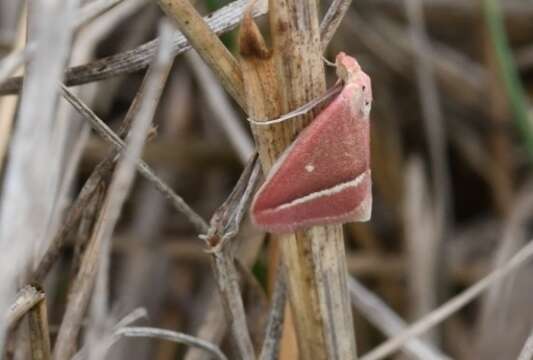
54 25 173 359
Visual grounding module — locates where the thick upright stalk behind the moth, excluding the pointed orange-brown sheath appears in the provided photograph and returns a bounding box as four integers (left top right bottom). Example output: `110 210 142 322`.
269 0 357 359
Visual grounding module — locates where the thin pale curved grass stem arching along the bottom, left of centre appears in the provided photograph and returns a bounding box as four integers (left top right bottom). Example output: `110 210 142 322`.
115 326 228 360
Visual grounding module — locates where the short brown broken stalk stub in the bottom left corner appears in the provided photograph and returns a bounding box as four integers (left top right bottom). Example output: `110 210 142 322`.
28 297 52 360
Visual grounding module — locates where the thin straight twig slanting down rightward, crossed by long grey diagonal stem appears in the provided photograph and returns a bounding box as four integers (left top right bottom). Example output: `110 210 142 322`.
61 85 208 233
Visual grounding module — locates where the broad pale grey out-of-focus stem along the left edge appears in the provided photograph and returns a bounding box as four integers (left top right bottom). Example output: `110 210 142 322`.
0 1 77 352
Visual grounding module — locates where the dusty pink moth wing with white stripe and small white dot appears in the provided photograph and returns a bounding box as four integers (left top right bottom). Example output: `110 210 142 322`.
251 80 372 232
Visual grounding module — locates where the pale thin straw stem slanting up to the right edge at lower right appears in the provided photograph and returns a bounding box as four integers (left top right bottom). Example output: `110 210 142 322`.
361 236 533 360
